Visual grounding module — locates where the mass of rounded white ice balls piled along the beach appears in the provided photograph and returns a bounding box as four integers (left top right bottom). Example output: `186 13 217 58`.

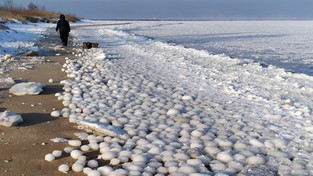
48 46 312 175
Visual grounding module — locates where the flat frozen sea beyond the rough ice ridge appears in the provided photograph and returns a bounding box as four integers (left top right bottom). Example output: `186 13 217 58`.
122 21 313 75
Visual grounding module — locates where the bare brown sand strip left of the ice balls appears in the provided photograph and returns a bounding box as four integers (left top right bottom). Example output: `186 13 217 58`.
0 28 82 176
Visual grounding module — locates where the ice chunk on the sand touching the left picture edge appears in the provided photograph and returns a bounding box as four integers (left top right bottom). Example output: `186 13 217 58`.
0 111 23 127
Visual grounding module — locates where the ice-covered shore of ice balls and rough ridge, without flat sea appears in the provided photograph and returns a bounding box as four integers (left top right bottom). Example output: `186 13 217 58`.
45 20 313 175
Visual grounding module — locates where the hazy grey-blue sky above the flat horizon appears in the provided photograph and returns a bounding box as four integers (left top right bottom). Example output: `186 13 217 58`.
0 0 313 19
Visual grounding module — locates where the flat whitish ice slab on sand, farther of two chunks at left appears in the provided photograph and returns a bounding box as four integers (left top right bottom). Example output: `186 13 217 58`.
9 82 46 96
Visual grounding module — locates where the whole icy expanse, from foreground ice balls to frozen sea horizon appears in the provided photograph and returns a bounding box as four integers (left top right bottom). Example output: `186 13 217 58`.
1 21 313 176
